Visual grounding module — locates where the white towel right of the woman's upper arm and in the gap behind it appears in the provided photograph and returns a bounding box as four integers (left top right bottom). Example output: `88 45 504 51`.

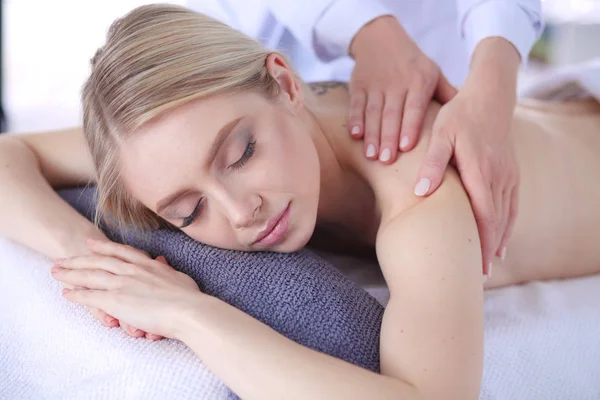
319 252 600 400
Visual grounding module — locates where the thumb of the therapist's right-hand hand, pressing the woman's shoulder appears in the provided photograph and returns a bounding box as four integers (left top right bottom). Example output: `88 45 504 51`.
415 127 454 196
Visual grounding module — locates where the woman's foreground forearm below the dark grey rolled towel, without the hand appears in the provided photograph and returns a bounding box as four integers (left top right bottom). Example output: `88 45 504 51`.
175 295 416 400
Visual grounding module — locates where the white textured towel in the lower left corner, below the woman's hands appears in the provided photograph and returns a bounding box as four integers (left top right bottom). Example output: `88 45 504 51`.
0 237 227 400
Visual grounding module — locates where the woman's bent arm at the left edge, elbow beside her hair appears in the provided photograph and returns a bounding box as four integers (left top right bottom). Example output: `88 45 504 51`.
0 128 104 257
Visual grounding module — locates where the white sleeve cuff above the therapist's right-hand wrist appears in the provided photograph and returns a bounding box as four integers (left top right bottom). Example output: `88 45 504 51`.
457 0 544 64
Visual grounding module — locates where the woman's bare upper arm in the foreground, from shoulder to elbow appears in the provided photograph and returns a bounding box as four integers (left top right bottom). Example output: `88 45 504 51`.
377 171 483 399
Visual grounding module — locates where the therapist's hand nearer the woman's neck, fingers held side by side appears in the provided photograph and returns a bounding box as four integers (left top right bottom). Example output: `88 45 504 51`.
348 16 456 164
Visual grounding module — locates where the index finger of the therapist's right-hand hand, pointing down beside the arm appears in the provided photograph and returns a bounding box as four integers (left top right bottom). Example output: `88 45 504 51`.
461 171 496 275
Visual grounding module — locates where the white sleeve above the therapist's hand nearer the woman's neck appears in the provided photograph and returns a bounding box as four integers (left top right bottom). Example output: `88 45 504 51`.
266 0 393 61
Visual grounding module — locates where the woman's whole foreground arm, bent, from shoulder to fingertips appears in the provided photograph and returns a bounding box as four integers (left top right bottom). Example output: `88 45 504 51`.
54 166 483 400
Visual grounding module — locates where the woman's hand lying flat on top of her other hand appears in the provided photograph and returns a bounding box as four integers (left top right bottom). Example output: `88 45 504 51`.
52 241 201 337
